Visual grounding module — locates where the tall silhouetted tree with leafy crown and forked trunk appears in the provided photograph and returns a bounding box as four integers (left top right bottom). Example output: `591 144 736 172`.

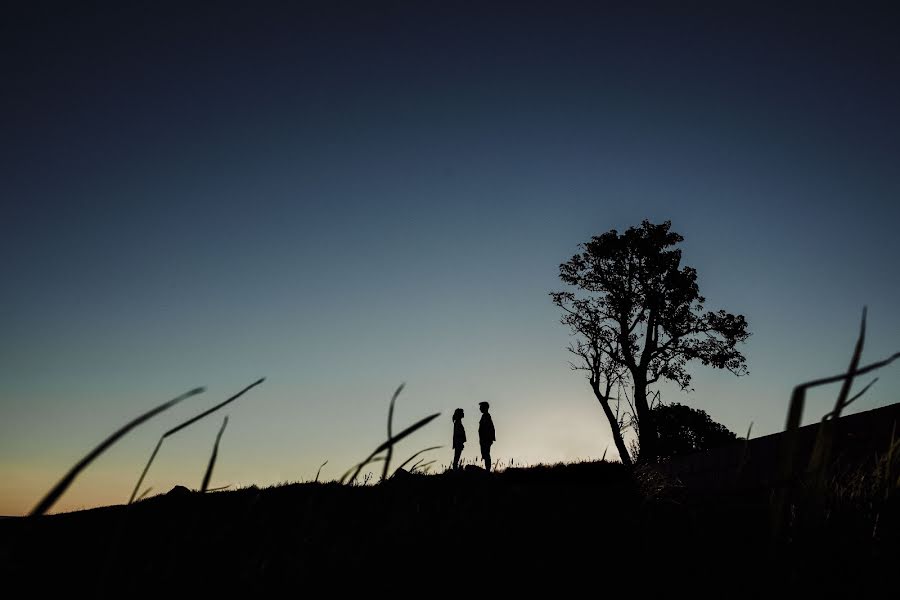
550 220 750 463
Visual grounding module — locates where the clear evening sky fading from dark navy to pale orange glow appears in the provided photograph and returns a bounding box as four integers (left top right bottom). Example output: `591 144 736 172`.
0 1 900 515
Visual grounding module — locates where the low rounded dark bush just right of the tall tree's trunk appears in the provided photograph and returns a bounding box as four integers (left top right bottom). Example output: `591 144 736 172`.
652 402 737 457
